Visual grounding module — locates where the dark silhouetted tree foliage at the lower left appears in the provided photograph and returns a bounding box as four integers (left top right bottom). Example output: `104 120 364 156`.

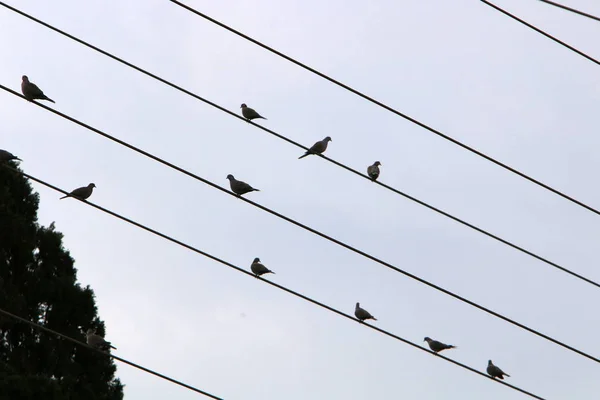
0 162 123 400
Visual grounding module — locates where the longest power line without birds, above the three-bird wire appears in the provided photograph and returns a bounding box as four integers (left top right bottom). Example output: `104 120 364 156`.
162 0 600 219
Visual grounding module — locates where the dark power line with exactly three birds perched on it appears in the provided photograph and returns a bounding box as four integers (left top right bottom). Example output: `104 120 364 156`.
0 6 600 287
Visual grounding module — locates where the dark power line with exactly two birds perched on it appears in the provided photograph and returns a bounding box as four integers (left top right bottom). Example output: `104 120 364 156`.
0 85 600 363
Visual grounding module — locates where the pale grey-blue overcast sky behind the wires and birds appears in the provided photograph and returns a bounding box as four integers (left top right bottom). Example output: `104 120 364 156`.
0 0 600 400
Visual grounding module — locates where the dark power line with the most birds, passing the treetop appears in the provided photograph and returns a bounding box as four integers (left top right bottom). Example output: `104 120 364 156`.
0 165 544 400
